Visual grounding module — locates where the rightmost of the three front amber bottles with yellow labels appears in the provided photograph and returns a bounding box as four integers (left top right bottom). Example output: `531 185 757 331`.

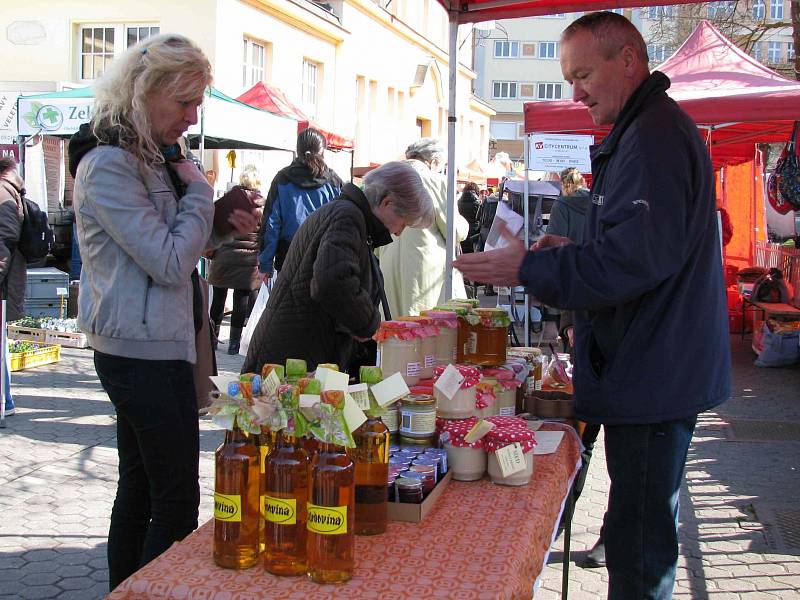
308 443 354 583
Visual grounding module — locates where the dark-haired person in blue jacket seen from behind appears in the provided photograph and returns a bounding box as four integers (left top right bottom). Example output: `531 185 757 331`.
258 127 342 282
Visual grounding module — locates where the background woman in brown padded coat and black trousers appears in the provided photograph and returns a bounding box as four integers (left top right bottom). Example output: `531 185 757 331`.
208 165 264 354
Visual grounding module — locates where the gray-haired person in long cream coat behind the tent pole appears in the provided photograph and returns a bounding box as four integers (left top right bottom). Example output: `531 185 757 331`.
378 138 469 316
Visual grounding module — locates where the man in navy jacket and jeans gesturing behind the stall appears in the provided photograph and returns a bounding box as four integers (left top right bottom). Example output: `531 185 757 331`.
455 12 731 600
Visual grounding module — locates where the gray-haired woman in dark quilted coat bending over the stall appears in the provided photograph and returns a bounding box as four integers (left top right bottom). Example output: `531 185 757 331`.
242 162 433 372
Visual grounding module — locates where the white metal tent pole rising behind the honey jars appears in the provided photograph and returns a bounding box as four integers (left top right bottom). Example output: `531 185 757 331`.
444 11 458 300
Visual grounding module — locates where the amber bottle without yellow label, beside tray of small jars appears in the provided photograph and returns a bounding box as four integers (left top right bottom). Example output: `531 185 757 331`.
347 417 389 535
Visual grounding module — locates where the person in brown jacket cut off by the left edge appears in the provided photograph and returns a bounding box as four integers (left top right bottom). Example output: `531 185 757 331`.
0 157 28 416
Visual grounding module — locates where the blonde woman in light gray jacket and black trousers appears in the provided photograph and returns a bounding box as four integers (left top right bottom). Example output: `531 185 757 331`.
69 34 256 590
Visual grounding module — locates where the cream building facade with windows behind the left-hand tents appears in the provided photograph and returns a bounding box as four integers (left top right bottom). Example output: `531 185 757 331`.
0 0 494 185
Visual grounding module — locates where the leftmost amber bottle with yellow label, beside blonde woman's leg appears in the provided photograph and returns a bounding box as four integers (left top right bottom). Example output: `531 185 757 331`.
214 424 261 569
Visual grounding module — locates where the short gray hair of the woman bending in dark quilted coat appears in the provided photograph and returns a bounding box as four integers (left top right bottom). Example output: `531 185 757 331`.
364 161 433 229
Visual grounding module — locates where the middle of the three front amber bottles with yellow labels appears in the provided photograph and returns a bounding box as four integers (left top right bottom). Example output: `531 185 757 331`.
264 432 308 575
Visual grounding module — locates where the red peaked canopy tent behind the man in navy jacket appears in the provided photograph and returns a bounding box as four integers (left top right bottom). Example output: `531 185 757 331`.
524 21 800 167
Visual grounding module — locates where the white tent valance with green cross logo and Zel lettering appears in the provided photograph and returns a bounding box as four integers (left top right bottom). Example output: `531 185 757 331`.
17 97 94 135
